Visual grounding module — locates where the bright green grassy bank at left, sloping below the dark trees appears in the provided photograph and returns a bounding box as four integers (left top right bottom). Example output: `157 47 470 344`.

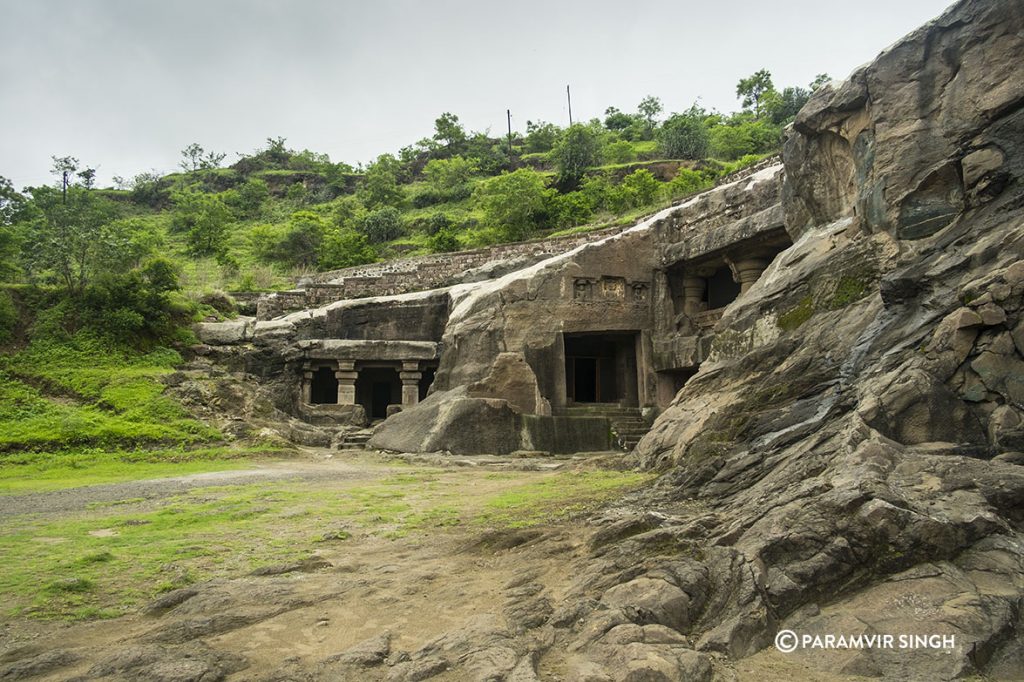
0 336 219 452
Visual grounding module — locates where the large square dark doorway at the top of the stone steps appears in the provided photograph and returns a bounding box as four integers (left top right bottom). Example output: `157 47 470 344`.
563 332 639 407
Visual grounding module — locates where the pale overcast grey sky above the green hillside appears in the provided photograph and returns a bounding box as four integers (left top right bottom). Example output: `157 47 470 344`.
0 0 949 187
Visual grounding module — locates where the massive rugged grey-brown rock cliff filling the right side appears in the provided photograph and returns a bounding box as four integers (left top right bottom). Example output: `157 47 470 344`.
578 2 1024 679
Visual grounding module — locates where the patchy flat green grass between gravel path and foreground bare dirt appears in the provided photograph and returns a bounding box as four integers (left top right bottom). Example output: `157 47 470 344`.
0 463 649 620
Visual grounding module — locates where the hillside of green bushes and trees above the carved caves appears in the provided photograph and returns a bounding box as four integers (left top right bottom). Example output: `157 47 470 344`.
0 71 820 307
